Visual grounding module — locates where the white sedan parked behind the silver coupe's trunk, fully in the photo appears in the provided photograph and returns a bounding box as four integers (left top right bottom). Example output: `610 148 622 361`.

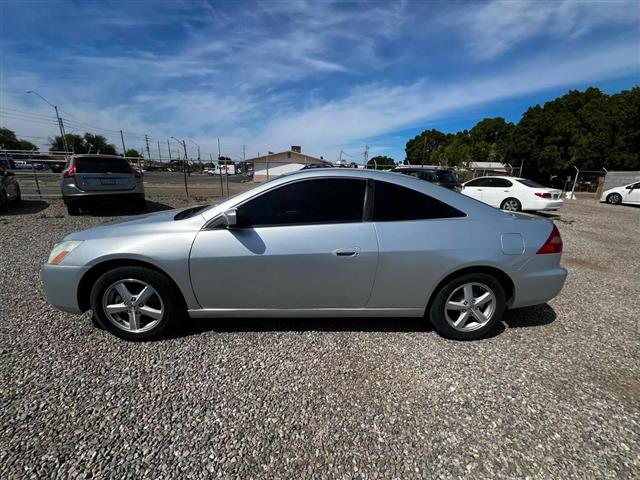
462 177 562 212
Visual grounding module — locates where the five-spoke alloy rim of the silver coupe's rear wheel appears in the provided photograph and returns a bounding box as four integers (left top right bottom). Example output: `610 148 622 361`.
444 282 496 332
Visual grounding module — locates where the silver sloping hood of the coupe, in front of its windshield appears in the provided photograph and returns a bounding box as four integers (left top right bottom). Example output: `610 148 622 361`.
64 208 205 240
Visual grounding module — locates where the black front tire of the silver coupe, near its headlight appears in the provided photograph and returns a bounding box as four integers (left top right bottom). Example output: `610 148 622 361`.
90 267 185 341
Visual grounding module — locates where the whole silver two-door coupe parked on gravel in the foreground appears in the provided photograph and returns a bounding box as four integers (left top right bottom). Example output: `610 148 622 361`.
42 169 567 340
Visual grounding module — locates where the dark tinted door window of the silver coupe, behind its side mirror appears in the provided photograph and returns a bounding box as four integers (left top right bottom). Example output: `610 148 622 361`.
238 178 366 226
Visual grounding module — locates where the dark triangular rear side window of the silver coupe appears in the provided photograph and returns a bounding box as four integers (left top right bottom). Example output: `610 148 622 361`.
373 181 465 222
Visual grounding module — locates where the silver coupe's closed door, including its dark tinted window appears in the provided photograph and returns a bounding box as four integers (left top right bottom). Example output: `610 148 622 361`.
189 178 378 313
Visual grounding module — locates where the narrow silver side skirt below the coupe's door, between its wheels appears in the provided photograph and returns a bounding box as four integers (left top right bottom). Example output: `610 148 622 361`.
189 308 424 318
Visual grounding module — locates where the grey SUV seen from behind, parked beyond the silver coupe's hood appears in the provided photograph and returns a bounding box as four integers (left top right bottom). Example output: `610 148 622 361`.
60 155 145 215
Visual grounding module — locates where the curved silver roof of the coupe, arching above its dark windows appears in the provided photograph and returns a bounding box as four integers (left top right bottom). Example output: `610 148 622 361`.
201 168 504 220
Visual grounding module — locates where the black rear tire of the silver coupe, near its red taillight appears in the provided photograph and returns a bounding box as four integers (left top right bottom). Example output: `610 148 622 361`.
428 273 506 340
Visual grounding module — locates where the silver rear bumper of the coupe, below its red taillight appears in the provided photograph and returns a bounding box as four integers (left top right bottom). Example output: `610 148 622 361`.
510 254 568 308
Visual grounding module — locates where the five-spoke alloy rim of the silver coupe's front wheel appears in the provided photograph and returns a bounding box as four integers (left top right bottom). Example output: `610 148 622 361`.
102 278 165 333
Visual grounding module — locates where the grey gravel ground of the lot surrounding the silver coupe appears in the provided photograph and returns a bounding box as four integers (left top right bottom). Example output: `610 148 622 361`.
0 198 640 479
